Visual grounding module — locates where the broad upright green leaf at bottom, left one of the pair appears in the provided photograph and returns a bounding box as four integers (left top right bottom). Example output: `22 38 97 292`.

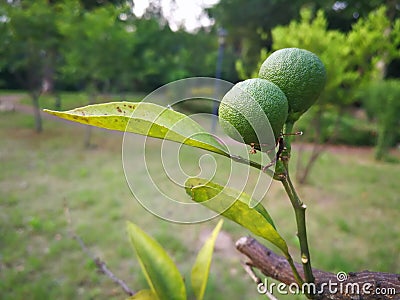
127 222 186 300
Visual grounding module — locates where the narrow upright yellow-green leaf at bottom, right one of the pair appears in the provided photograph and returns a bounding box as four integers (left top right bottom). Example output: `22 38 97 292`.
191 219 223 300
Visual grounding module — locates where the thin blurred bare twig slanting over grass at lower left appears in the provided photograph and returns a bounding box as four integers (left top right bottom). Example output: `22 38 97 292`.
64 201 135 296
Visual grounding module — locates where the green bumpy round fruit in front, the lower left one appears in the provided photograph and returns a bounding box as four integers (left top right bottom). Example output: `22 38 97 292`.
219 78 289 149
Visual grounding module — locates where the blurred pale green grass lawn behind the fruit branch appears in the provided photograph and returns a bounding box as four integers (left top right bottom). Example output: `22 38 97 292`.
0 107 400 299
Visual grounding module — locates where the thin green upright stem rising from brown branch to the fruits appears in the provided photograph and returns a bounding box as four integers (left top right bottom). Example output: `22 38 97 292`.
280 122 315 290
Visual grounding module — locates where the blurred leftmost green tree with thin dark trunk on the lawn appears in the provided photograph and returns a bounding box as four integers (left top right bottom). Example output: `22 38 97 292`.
0 0 60 132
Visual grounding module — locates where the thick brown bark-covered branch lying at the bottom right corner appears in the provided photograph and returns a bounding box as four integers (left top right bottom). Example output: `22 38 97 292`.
236 237 400 300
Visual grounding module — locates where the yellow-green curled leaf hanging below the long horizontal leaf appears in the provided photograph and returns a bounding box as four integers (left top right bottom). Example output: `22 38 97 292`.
185 178 289 257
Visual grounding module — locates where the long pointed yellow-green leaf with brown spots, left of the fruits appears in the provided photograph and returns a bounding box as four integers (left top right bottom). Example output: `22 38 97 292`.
44 102 230 157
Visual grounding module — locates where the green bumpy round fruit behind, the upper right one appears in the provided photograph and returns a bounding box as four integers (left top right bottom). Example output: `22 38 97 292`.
258 48 326 121
